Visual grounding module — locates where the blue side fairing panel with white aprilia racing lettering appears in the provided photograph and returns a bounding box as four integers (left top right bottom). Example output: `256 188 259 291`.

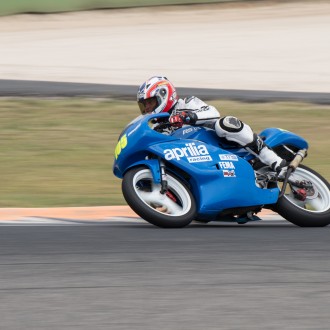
148 139 279 213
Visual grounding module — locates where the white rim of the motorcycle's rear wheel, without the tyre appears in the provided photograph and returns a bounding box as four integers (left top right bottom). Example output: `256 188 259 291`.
284 167 330 213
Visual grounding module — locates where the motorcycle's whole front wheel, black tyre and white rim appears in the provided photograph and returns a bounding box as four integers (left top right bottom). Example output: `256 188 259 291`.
122 166 196 228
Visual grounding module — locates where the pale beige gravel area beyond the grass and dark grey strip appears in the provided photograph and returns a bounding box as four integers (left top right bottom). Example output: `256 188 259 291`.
0 0 330 93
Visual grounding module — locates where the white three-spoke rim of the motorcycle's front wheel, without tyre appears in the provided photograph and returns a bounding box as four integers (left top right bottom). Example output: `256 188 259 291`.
133 169 191 217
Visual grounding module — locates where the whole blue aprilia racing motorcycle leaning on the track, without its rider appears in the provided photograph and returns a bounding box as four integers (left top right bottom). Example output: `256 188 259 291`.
113 113 330 228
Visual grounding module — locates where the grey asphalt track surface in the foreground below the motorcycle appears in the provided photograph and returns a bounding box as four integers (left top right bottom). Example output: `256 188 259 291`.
0 221 330 330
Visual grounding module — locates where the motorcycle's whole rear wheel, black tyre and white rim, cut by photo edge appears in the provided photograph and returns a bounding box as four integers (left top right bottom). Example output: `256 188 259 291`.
276 165 330 227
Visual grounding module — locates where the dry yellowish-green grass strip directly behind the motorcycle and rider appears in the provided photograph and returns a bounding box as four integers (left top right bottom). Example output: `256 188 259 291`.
0 98 330 207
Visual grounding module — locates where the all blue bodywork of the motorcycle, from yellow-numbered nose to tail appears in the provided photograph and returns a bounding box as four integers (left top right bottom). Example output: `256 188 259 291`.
113 114 307 216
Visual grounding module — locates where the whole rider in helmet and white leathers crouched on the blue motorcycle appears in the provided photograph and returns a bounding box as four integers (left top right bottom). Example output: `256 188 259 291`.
137 76 287 175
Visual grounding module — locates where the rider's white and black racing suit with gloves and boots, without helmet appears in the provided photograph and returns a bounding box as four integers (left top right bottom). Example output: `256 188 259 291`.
169 96 287 172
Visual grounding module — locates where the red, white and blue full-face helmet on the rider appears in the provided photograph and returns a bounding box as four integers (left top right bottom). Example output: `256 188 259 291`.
137 76 178 114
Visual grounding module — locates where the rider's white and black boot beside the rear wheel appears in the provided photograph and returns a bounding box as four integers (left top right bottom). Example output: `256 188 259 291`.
245 134 288 173
